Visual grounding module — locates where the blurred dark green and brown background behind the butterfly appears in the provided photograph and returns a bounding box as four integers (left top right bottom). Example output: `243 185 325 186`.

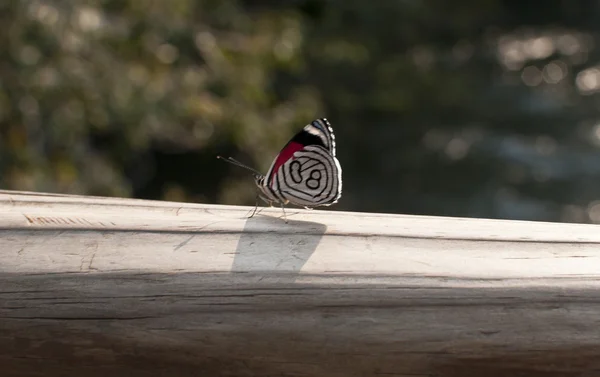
0 0 600 223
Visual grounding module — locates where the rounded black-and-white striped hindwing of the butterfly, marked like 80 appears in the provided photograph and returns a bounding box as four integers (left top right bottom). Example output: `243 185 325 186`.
272 145 342 207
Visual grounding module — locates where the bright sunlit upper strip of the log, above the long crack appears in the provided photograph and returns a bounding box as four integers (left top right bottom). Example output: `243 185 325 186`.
0 190 600 243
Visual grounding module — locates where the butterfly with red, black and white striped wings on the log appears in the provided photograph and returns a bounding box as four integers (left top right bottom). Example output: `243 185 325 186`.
217 118 342 222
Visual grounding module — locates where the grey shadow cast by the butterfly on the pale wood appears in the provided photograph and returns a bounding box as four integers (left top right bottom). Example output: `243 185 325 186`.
231 216 327 283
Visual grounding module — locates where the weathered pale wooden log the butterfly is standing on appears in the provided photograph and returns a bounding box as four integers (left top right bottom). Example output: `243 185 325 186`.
0 191 600 377
